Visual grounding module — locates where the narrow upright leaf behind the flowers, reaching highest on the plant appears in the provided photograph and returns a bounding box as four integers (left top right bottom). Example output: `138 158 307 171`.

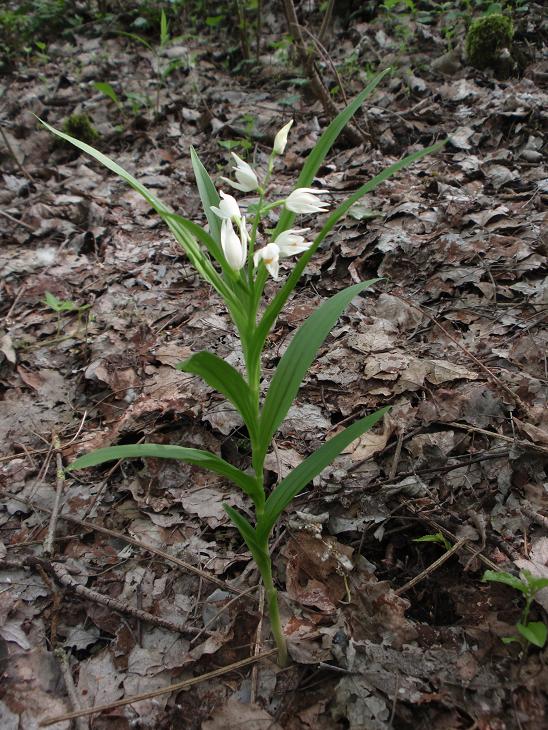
275 68 391 235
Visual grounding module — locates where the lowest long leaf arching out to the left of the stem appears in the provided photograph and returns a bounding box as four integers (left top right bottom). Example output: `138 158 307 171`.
67 444 257 498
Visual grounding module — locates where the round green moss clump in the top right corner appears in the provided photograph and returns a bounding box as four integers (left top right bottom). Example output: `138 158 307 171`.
465 15 514 69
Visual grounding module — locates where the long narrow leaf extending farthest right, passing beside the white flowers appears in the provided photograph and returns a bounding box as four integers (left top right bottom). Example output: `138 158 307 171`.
253 141 446 364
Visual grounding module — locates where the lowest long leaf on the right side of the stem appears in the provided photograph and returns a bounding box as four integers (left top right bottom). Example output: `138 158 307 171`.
256 407 389 540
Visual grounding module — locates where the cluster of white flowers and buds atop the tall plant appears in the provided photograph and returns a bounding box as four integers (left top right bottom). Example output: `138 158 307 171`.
211 120 328 279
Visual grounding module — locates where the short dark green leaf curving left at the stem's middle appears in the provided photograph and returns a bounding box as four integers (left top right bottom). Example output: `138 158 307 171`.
176 352 257 441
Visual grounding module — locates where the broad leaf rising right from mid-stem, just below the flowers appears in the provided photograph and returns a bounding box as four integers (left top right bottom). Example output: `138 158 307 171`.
260 279 379 455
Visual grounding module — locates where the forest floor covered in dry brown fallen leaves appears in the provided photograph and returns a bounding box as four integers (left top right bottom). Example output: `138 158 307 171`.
0 4 548 730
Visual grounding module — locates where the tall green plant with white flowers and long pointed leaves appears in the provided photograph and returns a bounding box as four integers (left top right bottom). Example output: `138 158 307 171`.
41 71 444 664
